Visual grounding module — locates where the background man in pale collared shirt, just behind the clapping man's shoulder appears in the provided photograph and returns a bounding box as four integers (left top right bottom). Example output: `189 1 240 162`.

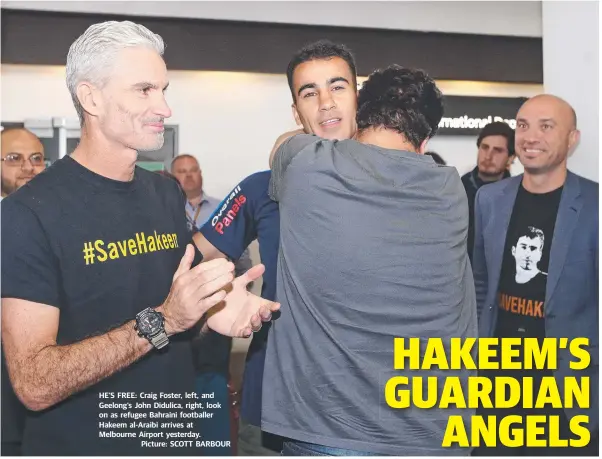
171 154 252 456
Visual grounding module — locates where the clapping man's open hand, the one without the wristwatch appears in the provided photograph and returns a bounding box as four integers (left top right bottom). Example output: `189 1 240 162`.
207 265 280 338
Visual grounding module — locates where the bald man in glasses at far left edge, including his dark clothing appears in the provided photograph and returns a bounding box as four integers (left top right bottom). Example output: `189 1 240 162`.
0 128 46 456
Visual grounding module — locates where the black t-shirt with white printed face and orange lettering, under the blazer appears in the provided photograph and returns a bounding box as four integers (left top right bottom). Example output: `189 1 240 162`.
496 185 562 398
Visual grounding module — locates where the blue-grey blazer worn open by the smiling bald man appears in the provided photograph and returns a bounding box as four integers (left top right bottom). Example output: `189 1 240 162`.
473 172 599 431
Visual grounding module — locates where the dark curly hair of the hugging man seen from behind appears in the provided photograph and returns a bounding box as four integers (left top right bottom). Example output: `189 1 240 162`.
357 65 443 149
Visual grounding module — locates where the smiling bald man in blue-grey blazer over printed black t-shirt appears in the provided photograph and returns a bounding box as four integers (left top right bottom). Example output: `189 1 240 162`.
473 95 599 456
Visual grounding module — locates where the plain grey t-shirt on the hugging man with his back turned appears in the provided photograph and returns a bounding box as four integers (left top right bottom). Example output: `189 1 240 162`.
262 135 477 456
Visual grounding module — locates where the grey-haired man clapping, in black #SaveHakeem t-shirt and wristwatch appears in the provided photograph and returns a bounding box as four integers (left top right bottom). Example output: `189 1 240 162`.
1 21 278 456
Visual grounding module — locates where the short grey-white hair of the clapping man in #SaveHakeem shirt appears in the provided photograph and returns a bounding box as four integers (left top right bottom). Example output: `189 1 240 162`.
67 21 165 126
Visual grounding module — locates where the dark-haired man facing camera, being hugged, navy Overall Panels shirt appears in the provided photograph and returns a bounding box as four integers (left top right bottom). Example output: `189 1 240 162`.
194 40 357 456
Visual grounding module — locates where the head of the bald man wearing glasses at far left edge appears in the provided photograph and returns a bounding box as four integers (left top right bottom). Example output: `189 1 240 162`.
2 128 46 198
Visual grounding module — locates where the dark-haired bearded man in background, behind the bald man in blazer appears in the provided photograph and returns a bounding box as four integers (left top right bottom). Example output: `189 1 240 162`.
462 121 514 261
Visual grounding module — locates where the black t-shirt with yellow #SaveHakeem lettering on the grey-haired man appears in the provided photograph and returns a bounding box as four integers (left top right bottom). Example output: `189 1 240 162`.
1 157 197 456
